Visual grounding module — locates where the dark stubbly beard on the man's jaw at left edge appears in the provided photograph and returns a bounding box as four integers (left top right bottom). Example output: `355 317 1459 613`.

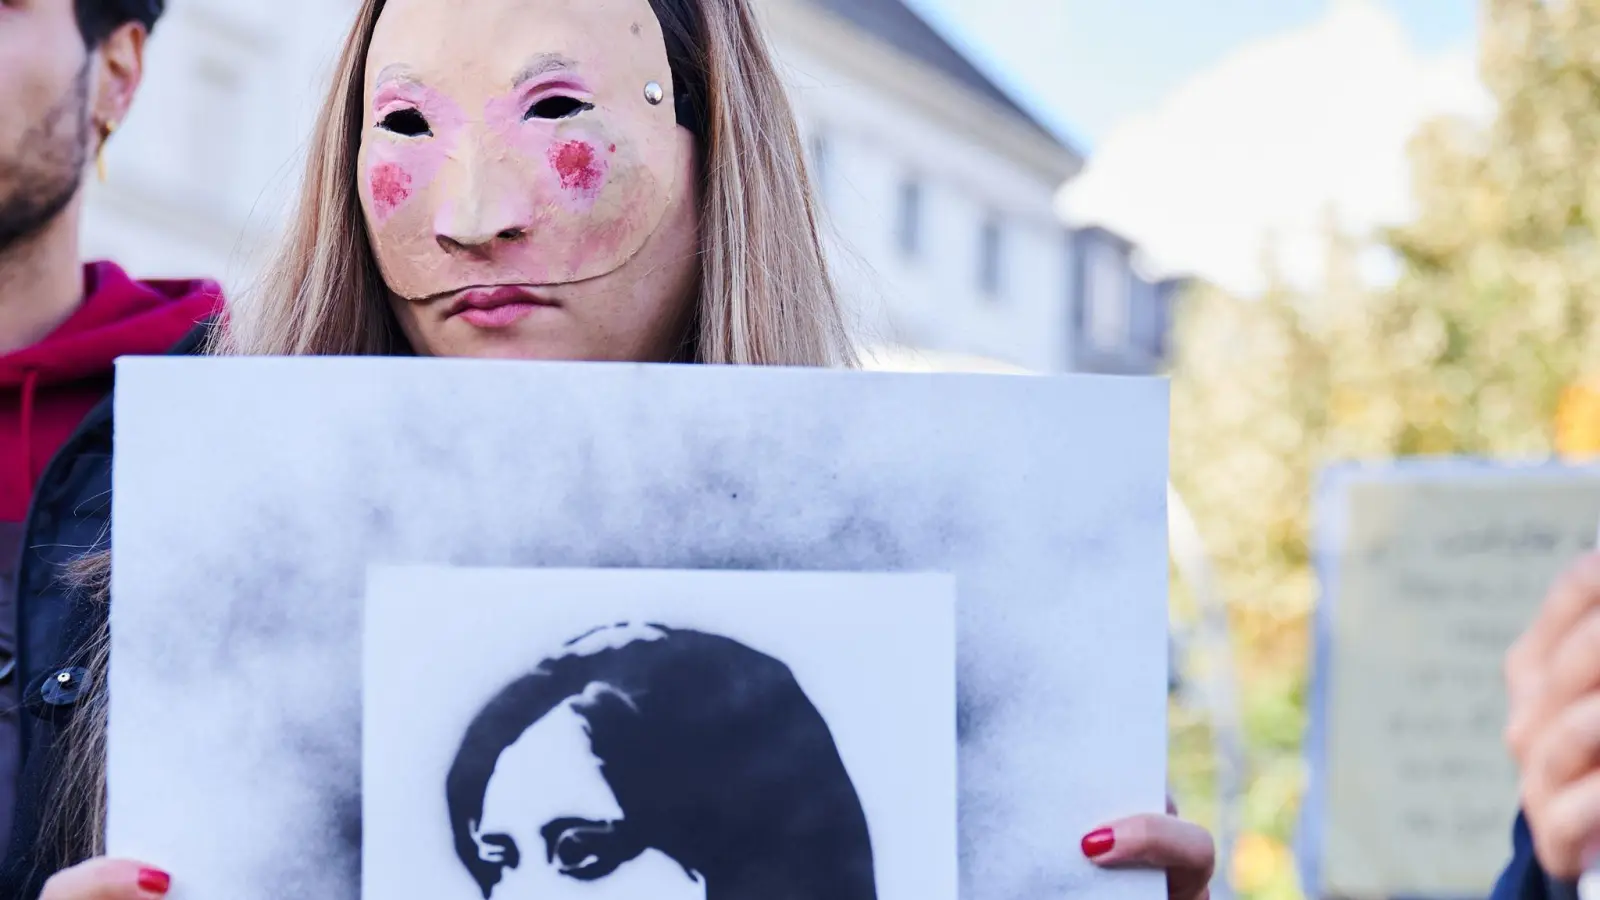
0 62 90 253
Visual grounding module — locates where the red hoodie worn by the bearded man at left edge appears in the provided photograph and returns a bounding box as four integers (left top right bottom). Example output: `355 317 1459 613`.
0 263 222 522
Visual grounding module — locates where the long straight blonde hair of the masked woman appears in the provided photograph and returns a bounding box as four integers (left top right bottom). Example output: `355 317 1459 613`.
40 0 856 862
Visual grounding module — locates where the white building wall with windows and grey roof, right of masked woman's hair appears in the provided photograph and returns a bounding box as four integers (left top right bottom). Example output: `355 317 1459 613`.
766 0 1083 372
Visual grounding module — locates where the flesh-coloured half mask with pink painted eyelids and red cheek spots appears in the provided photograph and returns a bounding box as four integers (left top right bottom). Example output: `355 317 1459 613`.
358 0 693 301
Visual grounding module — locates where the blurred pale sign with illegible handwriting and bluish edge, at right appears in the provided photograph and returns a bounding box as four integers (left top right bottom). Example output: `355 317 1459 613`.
1299 460 1600 898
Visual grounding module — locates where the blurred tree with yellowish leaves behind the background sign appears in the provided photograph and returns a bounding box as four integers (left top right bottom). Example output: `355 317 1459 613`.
1173 0 1600 900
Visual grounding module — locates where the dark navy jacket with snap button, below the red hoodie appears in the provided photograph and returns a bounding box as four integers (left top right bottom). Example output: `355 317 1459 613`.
0 325 206 900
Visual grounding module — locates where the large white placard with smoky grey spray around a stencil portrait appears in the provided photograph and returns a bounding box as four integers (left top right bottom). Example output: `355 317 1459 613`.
107 357 1168 900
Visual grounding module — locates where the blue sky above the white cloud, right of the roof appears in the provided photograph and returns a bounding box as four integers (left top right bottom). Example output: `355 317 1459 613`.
909 0 1477 151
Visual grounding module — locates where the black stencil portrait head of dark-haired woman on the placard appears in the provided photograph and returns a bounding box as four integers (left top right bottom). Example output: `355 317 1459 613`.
445 625 877 900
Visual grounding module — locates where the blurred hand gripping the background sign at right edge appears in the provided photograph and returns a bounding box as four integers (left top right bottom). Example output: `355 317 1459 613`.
1506 554 1600 881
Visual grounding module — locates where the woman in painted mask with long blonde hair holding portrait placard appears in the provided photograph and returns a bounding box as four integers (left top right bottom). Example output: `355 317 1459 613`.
9 0 1213 900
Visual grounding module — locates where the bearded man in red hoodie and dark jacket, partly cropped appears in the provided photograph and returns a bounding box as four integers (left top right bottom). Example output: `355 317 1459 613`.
0 0 221 871
